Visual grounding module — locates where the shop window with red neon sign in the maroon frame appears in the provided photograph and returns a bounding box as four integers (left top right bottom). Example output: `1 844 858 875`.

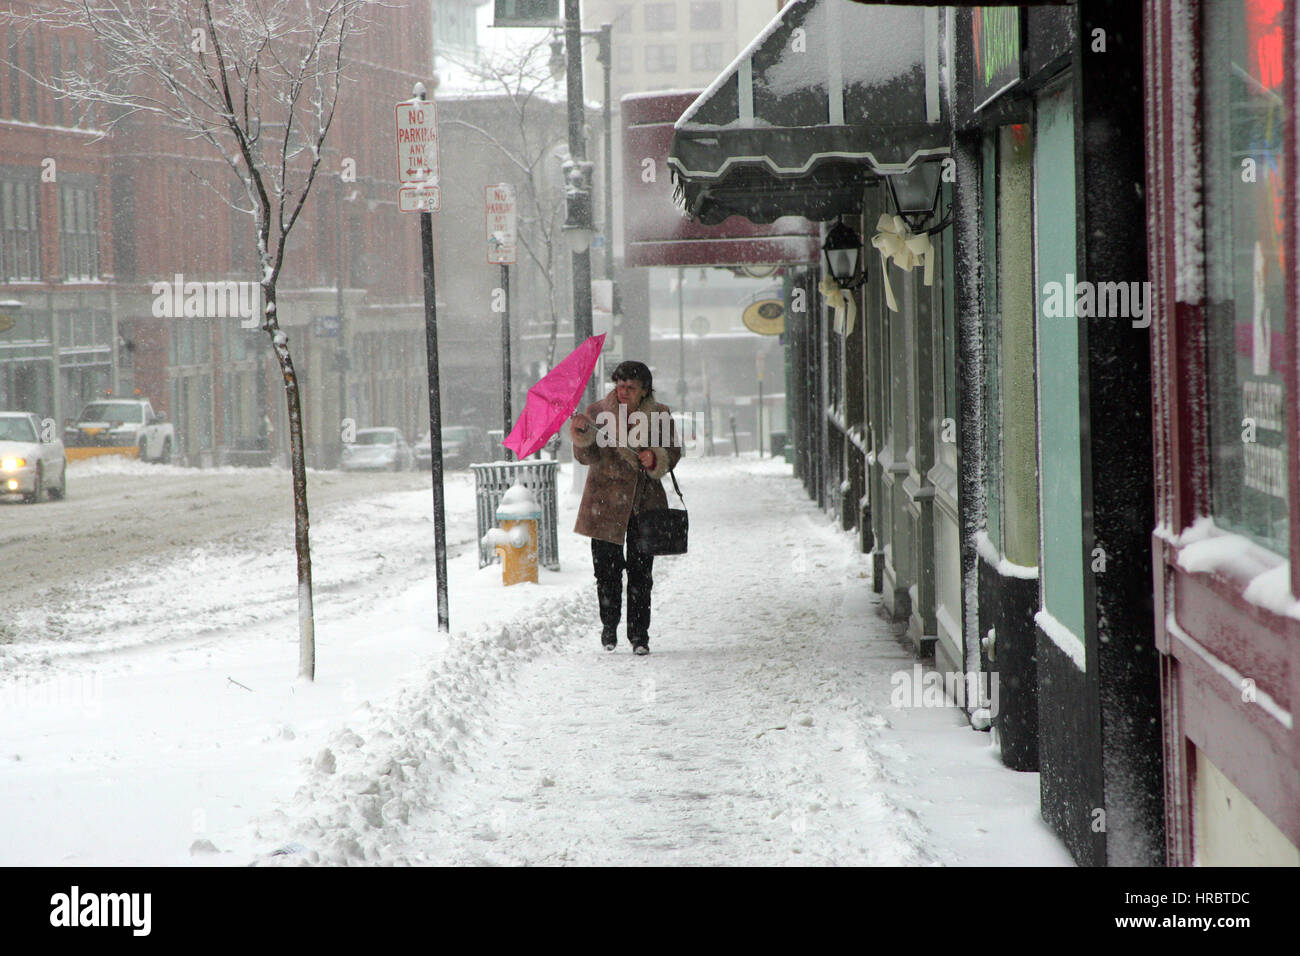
1204 0 1295 555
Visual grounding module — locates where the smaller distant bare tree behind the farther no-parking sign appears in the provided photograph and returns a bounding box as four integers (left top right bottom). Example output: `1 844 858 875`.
439 39 568 365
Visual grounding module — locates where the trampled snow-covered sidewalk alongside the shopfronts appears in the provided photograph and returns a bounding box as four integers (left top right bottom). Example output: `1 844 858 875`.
256 459 1070 865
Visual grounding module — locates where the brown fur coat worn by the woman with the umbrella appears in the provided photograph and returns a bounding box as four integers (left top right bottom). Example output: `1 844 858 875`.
569 389 681 545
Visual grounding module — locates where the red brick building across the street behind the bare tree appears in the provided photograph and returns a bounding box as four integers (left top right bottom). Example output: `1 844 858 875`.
0 0 432 464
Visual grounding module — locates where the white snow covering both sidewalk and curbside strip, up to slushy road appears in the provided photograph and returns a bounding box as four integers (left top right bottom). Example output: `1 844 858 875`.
0 458 1071 865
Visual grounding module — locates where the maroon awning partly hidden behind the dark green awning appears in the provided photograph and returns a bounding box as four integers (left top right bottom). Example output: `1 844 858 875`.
620 90 820 267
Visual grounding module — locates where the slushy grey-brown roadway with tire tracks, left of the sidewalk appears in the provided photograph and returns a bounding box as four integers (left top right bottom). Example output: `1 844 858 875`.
0 457 452 678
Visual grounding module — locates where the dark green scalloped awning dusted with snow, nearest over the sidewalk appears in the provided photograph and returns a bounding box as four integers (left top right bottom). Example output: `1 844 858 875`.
668 0 949 222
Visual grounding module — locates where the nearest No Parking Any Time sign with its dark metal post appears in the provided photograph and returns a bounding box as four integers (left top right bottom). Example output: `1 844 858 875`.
397 83 451 633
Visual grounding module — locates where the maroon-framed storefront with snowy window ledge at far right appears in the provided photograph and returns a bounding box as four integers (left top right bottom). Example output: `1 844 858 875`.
1143 0 1300 866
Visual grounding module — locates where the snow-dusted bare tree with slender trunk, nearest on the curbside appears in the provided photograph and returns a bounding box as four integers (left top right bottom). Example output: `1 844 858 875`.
0 0 372 680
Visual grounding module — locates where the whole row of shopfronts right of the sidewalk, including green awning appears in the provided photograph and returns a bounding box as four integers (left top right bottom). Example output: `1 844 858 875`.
670 0 1300 865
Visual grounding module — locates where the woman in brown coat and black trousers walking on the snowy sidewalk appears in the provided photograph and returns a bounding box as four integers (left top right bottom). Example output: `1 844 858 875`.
569 362 681 654
